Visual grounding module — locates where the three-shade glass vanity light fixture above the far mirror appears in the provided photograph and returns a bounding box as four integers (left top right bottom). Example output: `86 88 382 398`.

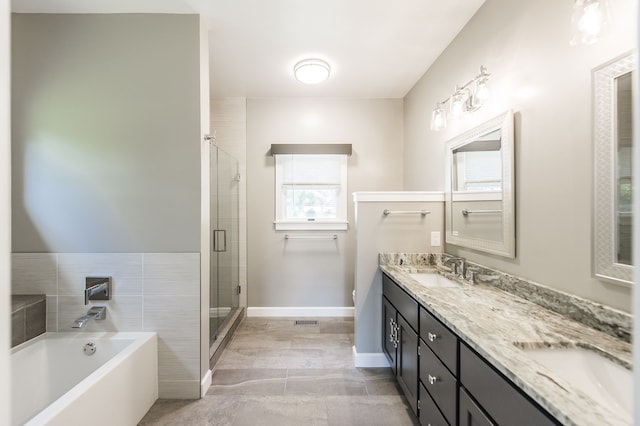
431 66 491 132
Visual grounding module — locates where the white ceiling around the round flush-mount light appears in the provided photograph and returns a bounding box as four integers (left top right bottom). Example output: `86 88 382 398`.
12 0 484 98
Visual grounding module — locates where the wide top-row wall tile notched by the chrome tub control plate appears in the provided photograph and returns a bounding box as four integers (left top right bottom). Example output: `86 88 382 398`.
58 253 142 296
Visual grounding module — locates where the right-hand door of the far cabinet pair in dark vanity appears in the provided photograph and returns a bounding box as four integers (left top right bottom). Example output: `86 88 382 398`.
396 314 418 415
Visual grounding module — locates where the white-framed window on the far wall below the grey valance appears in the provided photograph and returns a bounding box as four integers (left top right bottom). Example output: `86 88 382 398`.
275 154 347 230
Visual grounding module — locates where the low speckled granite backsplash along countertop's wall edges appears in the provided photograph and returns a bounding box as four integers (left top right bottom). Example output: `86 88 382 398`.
379 253 633 342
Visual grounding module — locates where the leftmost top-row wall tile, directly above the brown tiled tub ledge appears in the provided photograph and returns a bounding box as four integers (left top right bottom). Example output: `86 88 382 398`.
11 253 58 295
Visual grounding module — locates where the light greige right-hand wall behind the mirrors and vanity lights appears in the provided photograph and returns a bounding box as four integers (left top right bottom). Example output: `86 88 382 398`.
404 0 636 311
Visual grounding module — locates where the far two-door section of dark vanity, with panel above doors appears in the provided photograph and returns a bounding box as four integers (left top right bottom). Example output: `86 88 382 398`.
382 275 418 415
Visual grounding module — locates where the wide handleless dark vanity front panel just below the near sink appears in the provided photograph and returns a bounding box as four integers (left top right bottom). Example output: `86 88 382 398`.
459 343 558 426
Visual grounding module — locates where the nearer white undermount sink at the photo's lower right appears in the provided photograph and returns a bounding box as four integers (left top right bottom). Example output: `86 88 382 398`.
521 347 633 424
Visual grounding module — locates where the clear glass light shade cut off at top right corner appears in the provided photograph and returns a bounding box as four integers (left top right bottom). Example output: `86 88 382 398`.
570 0 610 46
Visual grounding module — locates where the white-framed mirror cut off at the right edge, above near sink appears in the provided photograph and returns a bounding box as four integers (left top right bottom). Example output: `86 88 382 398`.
592 53 635 284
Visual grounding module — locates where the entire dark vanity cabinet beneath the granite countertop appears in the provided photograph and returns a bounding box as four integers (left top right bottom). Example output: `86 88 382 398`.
382 274 560 426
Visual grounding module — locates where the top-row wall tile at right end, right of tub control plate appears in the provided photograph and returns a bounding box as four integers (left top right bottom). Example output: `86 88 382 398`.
144 253 200 295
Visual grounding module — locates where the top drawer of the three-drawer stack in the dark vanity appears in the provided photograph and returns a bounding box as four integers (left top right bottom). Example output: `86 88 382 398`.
420 307 458 376
